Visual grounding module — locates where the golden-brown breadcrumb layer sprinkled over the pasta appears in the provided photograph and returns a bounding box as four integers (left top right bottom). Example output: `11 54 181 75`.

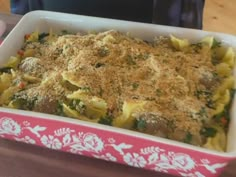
14 30 221 142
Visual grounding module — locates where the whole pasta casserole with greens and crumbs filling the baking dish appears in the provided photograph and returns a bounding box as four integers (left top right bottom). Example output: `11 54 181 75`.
0 30 235 151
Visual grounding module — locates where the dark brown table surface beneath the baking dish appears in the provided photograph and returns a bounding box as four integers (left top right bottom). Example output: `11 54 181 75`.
0 14 236 177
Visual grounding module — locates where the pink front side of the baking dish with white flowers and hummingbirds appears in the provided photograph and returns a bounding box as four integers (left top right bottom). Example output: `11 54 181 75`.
0 112 236 177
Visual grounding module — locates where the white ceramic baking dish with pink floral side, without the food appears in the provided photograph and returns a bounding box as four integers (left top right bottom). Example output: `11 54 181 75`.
0 11 236 176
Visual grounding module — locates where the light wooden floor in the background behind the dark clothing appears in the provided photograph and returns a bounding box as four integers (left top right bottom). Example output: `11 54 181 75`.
0 0 236 35
